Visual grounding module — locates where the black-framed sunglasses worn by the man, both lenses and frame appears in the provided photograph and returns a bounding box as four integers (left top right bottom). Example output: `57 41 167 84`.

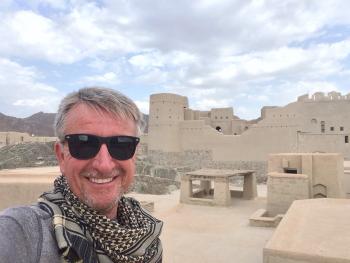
64 134 140 161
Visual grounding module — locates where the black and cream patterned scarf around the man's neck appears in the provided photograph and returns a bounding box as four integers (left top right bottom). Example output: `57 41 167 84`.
39 176 163 263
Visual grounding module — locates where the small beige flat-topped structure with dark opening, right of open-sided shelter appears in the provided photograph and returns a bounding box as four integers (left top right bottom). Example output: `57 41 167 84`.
267 153 347 216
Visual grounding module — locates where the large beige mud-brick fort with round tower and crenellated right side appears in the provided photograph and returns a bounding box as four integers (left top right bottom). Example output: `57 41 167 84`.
148 92 350 166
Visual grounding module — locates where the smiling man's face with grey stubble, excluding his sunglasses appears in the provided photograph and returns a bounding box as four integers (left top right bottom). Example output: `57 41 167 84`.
55 104 136 218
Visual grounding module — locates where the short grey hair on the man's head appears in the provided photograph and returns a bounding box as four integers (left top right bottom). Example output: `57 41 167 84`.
54 87 142 141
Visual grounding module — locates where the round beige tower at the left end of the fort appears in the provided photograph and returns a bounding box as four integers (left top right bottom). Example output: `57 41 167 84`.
148 93 188 152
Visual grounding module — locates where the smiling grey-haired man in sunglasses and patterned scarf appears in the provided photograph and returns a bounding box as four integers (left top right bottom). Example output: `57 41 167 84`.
0 88 162 263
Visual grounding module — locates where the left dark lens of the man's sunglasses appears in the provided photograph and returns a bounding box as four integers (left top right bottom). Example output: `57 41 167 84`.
66 134 100 160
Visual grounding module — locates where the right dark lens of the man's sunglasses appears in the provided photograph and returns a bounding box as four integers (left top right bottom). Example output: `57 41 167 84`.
108 136 138 161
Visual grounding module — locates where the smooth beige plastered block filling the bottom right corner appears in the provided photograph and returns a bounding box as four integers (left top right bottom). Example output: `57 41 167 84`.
263 198 350 263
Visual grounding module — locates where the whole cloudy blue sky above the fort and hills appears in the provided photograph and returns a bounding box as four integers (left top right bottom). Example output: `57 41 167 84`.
0 0 350 119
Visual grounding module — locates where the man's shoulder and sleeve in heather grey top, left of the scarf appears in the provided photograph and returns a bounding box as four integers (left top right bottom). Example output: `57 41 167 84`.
0 205 59 262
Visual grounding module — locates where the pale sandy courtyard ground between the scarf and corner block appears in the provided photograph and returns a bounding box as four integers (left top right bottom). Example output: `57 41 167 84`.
130 185 275 263
